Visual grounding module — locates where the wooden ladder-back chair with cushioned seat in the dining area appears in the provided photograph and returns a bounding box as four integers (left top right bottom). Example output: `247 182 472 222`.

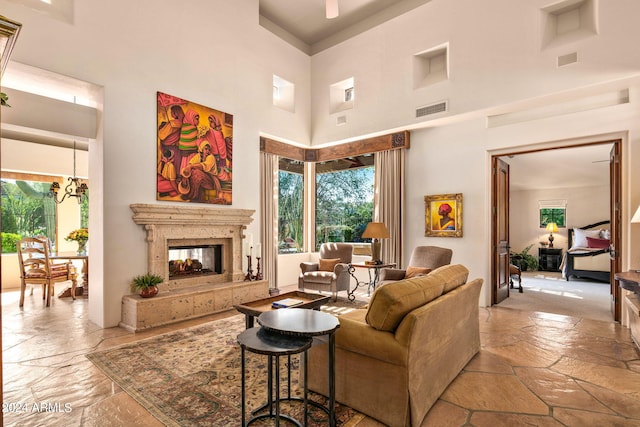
17 237 77 307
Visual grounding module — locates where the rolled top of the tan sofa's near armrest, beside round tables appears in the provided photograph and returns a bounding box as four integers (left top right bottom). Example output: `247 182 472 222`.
336 309 407 366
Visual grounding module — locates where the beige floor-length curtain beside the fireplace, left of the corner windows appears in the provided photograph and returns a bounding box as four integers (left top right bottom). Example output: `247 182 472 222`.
260 152 278 292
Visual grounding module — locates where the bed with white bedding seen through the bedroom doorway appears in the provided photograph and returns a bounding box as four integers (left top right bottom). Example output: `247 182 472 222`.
560 220 611 283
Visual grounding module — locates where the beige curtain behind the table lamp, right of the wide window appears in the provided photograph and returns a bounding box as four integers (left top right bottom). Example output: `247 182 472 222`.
374 148 406 268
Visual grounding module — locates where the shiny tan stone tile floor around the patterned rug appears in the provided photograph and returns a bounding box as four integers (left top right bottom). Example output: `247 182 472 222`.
2 291 640 427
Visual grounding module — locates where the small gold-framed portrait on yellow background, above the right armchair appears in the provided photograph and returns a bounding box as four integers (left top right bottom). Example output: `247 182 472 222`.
424 193 462 237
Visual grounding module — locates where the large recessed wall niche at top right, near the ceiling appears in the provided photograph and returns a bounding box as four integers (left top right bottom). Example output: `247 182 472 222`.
542 0 598 47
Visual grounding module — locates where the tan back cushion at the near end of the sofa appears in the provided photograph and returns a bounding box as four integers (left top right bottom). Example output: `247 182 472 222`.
366 273 445 332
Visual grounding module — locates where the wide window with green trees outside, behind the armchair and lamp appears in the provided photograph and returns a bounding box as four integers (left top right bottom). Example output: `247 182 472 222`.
316 154 374 250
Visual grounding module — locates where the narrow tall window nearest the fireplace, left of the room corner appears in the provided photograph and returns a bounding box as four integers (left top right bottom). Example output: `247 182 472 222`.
278 158 304 254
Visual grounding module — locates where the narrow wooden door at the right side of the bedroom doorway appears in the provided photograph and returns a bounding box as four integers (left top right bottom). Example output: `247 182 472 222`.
609 140 622 322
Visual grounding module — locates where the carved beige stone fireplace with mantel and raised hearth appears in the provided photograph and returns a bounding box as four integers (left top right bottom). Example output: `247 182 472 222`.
120 204 269 331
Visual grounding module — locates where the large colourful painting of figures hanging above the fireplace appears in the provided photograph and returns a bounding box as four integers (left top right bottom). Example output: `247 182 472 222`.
157 92 233 205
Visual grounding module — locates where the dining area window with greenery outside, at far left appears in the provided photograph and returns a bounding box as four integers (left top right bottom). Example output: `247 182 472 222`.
1 177 56 253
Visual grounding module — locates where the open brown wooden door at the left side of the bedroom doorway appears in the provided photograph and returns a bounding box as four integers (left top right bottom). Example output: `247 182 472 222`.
491 157 510 304
